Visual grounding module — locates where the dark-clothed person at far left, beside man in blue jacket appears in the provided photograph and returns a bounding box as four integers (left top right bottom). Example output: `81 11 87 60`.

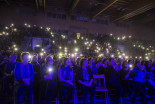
4 54 18 96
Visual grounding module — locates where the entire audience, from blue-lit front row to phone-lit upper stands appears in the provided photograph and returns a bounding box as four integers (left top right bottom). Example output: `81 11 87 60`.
0 24 155 104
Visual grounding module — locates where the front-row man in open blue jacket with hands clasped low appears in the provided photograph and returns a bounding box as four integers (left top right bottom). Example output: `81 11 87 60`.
15 52 34 104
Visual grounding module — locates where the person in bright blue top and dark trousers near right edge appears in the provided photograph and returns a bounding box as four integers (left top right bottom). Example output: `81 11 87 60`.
132 60 146 104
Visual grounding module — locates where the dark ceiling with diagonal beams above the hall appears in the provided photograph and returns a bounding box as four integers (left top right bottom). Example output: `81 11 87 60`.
0 0 155 26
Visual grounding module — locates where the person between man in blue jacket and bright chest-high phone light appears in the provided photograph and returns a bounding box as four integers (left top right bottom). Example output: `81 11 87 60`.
31 54 41 103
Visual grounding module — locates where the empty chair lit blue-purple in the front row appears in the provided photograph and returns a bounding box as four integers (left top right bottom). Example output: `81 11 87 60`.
93 74 109 104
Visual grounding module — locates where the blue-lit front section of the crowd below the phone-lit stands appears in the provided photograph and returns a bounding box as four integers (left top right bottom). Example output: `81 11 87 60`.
0 52 155 104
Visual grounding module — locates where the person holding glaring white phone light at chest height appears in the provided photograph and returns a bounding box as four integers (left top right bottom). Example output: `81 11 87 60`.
40 55 57 103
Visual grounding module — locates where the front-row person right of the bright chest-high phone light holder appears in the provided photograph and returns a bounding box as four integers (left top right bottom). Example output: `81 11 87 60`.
58 58 74 104
